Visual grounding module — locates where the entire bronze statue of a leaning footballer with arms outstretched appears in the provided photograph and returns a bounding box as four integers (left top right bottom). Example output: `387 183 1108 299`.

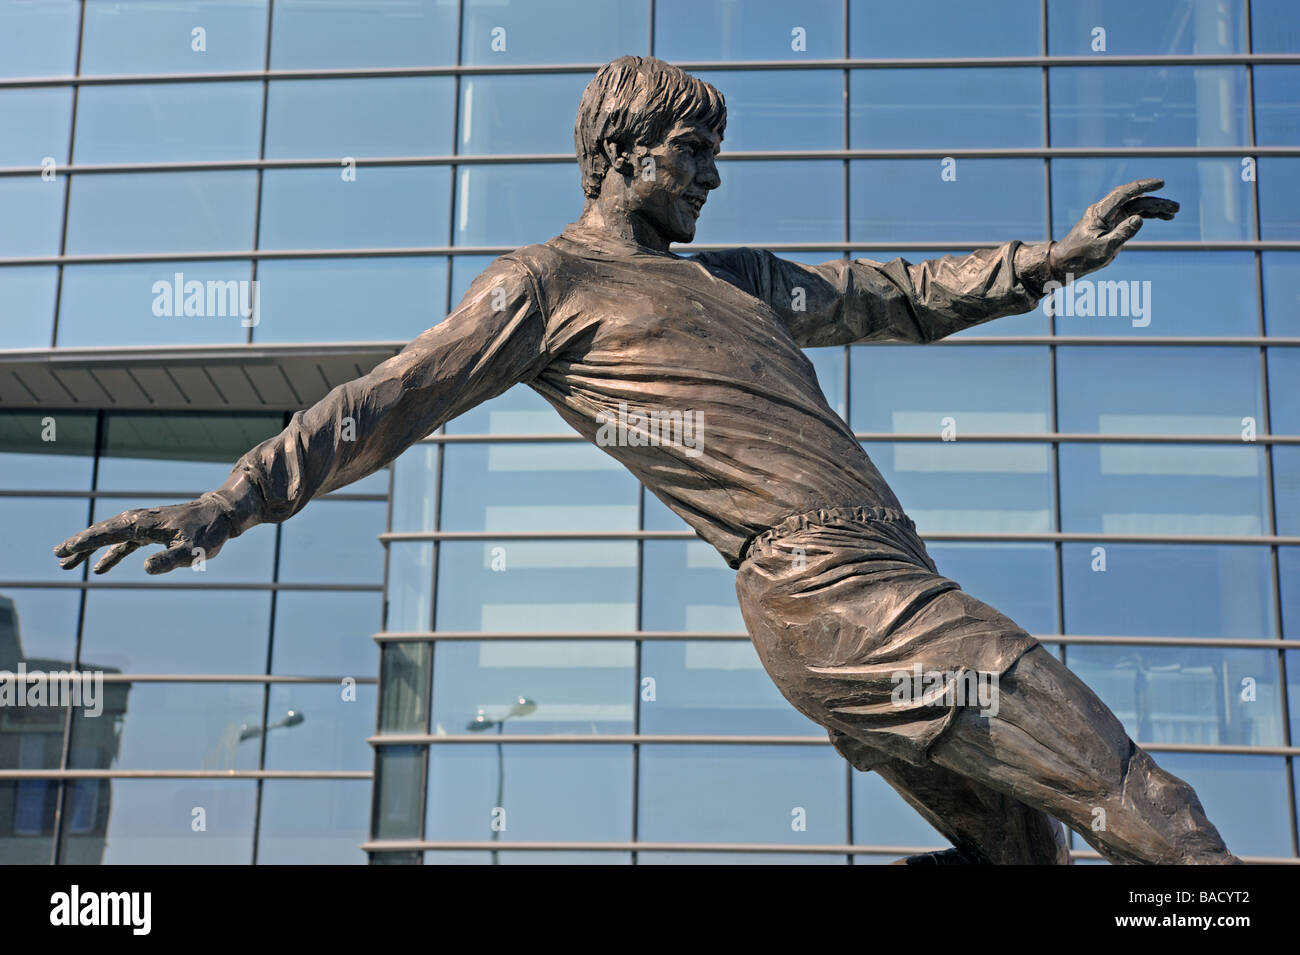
55 56 1238 864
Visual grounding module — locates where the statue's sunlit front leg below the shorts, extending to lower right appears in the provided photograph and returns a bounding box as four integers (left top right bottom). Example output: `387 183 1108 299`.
930 647 1239 864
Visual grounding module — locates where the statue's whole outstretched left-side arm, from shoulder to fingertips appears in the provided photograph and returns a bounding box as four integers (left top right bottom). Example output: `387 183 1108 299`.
55 257 547 573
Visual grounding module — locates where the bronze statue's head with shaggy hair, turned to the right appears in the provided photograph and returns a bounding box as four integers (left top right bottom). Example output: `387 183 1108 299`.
573 56 727 242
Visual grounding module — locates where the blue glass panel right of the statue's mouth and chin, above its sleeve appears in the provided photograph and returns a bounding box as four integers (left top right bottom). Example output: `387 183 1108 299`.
696 160 844 246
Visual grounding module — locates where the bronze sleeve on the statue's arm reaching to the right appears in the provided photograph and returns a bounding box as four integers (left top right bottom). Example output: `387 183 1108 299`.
696 240 1050 347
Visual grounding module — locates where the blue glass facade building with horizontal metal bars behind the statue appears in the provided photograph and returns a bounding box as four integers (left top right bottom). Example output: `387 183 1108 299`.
0 0 1300 864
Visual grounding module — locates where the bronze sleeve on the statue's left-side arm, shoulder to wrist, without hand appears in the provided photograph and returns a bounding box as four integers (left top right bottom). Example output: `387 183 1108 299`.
213 256 549 534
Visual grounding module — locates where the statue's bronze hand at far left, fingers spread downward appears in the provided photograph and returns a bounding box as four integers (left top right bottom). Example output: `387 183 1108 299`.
55 494 233 574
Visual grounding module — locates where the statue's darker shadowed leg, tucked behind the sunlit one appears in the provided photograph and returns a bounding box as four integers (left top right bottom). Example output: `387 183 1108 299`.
831 730 1070 865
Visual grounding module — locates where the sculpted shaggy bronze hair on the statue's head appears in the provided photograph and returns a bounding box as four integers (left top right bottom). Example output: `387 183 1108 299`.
573 56 727 199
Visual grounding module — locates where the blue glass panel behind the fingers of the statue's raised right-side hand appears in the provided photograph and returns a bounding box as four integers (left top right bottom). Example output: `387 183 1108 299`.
1052 156 1248 242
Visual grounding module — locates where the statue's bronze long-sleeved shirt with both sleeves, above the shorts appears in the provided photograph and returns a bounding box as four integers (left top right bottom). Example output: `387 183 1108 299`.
217 225 1049 567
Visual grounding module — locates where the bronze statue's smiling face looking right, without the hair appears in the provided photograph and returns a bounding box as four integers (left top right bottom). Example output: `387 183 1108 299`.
628 122 723 242
